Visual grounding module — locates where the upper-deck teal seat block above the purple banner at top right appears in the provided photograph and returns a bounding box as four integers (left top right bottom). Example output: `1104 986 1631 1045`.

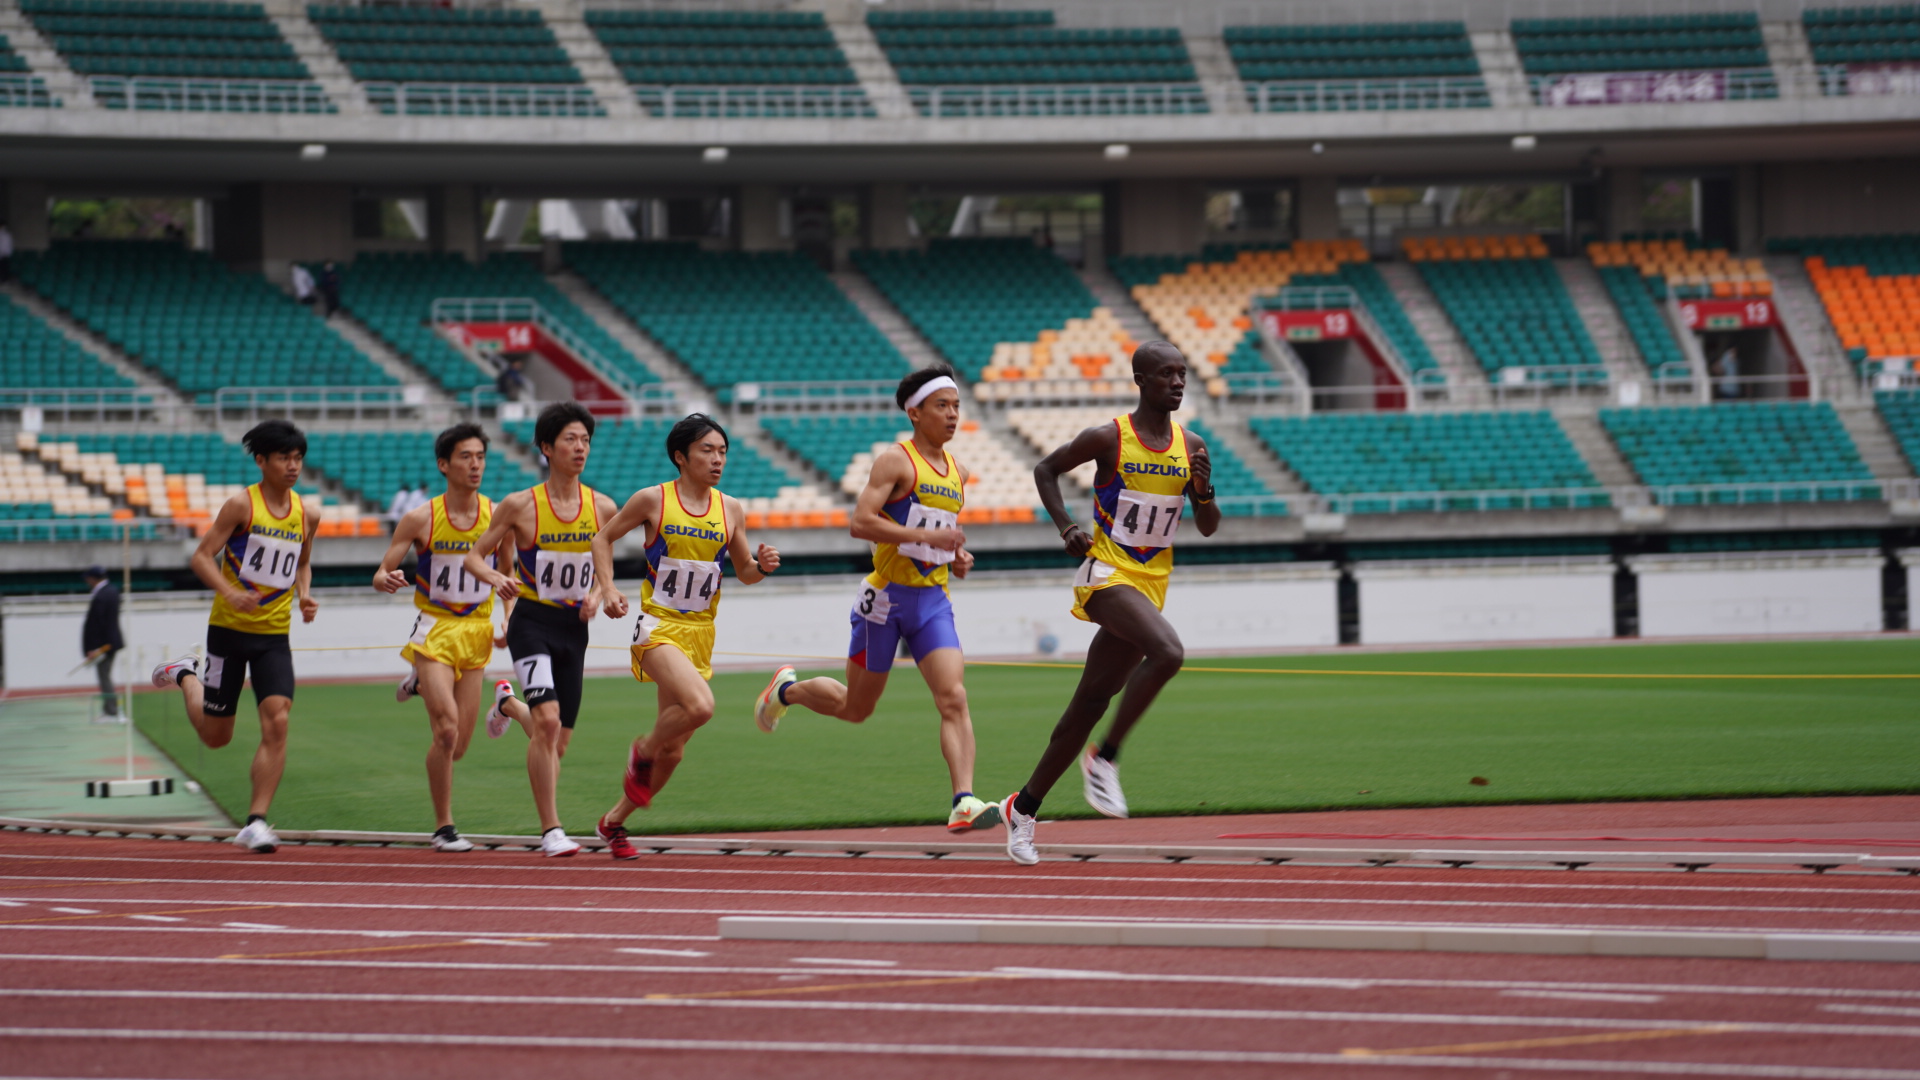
1513 12 1766 75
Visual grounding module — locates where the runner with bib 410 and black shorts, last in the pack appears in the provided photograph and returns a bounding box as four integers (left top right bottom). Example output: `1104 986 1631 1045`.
154 421 321 855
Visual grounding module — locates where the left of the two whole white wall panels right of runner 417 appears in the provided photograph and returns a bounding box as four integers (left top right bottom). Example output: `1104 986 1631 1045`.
1354 555 1613 646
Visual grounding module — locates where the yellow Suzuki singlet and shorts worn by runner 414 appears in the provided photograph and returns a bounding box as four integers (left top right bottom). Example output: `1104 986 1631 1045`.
632 480 728 682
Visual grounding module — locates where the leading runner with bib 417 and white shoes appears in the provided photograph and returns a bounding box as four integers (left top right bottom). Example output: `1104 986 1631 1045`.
1000 342 1219 865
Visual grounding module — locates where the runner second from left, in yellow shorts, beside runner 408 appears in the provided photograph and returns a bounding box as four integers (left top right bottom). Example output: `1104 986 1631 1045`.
372 423 513 851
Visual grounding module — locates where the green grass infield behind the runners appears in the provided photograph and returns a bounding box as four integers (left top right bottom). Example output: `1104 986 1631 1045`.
136 638 1920 834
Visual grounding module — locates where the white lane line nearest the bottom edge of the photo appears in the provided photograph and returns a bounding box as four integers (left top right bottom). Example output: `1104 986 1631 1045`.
0 1028 1920 1080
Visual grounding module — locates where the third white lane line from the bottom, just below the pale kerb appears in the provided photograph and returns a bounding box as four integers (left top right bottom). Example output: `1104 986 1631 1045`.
0 953 1920 1001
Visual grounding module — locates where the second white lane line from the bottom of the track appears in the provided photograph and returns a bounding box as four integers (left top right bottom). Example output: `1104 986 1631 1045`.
0 972 1920 1038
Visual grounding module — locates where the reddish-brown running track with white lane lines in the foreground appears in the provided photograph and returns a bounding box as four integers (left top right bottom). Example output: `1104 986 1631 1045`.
0 832 1920 1080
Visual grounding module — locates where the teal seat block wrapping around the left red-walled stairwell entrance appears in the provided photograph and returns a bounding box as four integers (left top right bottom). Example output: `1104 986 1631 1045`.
340 252 659 394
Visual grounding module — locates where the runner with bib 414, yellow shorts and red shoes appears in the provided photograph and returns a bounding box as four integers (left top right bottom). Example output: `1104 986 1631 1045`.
589 413 780 859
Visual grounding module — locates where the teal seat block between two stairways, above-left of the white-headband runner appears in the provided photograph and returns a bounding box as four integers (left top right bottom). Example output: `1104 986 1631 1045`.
564 242 908 400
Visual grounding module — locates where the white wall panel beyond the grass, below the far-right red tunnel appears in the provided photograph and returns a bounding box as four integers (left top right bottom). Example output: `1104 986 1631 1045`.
1632 552 1882 638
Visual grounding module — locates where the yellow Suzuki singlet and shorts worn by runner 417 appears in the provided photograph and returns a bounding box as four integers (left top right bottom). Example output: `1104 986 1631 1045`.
1073 417 1187 619
